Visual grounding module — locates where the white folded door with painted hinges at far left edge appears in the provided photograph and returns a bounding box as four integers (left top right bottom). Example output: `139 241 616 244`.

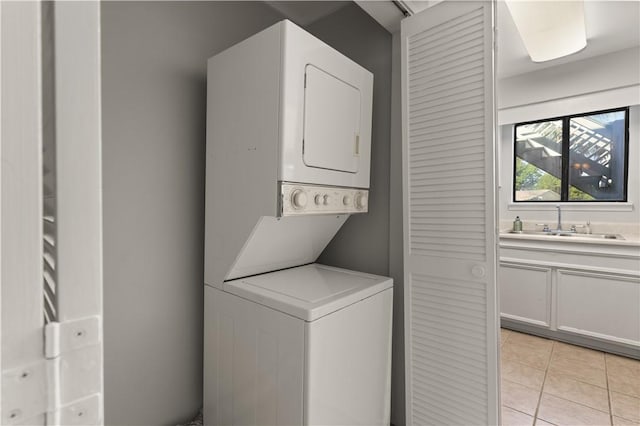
0 2 104 425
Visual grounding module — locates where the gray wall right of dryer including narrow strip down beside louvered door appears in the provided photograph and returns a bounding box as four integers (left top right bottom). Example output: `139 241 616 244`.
307 5 405 426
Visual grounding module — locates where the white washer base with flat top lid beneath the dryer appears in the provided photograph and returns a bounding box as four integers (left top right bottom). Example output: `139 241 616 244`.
204 264 393 425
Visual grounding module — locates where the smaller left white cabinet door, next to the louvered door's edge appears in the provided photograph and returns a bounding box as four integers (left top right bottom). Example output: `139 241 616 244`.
498 264 551 327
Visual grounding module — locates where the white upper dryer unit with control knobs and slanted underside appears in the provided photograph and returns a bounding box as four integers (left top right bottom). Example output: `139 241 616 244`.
205 20 373 288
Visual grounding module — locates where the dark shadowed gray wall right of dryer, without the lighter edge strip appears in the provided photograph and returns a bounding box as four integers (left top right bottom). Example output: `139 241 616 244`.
307 4 391 275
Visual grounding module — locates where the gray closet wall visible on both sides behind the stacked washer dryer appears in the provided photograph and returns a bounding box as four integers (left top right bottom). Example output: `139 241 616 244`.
101 2 391 425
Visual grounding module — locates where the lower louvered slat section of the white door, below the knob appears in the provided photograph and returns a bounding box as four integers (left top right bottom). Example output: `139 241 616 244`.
410 274 489 424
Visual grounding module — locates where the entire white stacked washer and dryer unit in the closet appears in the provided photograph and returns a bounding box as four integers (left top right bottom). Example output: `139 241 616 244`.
204 21 393 425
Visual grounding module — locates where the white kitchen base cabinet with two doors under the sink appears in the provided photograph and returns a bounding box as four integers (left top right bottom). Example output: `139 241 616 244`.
498 237 640 356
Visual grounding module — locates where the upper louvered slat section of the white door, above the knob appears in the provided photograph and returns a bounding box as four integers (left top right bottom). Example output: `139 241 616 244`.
407 6 484 261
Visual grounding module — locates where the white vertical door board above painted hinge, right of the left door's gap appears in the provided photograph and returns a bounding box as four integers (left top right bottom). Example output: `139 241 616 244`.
54 2 102 321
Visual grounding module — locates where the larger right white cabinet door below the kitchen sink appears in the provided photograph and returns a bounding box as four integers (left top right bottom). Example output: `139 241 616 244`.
557 269 640 345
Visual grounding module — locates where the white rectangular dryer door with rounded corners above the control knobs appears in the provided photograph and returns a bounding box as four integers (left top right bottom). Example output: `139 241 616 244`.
302 65 361 173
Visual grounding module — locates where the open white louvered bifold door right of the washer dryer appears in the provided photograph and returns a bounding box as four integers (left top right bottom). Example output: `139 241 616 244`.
402 1 499 425
